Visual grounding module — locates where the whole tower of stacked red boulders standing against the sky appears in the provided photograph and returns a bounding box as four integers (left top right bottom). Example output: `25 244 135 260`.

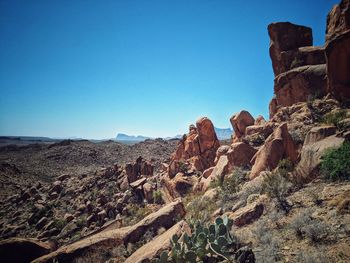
268 22 327 118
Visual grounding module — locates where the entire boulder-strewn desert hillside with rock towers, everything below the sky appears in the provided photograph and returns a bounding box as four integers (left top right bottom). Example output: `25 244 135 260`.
0 0 350 263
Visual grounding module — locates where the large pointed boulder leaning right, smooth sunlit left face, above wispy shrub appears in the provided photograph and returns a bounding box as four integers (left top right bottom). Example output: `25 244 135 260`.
249 123 298 179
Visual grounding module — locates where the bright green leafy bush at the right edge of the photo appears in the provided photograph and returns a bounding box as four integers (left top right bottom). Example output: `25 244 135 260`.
320 142 350 181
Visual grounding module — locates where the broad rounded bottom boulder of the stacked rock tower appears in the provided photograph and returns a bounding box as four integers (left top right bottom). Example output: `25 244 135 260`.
274 64 327 108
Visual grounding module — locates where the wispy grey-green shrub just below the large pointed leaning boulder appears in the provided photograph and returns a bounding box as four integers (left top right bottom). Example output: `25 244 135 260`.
262 171 291 213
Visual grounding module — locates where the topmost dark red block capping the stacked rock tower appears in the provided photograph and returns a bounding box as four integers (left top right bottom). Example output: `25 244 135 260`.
268 22 313 76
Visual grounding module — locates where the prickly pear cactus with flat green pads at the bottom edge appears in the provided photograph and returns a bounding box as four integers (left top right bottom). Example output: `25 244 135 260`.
152 217 255 263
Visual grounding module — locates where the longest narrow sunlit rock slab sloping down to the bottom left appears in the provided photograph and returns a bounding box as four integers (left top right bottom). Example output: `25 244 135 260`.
33 201 185 263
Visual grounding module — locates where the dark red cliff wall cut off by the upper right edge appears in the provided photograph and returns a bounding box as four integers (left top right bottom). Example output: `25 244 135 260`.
326 0 350 99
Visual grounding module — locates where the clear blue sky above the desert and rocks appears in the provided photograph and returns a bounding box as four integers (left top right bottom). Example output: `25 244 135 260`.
0 0 339 138
